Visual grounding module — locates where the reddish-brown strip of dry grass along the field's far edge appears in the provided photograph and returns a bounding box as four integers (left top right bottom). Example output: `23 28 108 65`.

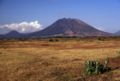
0 38 120 49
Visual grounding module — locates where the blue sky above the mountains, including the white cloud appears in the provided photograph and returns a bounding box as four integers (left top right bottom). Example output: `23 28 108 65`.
0 0 120 34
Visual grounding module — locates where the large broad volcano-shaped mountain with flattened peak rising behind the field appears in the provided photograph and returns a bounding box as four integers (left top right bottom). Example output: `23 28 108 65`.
30 18 111 37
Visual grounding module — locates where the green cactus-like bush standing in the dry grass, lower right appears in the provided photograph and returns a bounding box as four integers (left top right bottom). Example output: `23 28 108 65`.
85 59 111 75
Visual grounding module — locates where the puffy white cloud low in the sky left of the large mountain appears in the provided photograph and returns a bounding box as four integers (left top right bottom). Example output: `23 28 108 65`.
0 21 43 33
